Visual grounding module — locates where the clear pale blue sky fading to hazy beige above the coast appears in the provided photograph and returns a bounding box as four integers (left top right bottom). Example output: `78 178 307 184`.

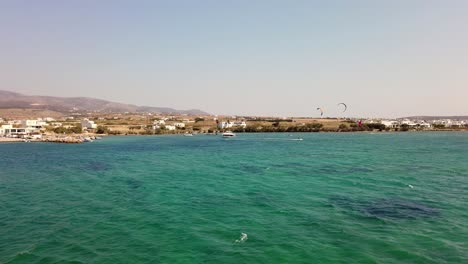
0 0 468 117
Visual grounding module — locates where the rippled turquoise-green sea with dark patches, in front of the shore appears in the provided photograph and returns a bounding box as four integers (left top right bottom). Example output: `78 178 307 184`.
0 132 468 263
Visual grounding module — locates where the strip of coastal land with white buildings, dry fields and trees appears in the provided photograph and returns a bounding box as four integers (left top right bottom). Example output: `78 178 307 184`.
0 113 468 143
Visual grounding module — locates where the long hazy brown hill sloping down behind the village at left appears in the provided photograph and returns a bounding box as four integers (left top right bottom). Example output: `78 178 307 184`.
0 90 208 115
